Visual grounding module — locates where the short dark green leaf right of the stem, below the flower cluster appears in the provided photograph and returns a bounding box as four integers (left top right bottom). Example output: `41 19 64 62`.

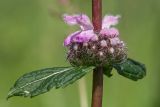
113 58 146 81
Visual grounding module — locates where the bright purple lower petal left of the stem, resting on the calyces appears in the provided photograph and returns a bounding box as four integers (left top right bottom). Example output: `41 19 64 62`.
72 30 96 43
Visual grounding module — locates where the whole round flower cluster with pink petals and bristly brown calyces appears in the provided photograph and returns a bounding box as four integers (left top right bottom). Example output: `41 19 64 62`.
64 14 127 66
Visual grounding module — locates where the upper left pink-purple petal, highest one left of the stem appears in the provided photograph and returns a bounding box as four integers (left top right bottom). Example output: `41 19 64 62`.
63 14 93 30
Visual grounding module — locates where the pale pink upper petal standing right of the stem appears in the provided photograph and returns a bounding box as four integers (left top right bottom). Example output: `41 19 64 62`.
102 15 120 29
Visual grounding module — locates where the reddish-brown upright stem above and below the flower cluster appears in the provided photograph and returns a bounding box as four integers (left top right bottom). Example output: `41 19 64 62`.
91 0 103 107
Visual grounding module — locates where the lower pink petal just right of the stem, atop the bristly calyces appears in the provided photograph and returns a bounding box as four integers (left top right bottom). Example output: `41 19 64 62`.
100 28 119 38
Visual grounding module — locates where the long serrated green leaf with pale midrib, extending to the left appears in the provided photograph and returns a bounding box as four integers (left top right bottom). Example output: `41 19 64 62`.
7 66 94 98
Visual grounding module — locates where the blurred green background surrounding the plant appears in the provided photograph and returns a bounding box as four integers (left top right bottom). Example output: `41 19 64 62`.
0 0 160 107
